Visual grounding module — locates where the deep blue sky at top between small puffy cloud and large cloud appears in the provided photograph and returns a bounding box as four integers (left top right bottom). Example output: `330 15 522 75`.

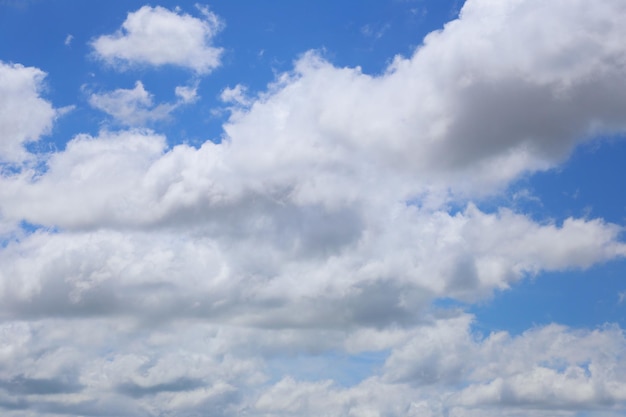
212 0 455 74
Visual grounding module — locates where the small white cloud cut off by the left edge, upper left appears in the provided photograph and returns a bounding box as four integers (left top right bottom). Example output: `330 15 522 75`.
0 61 58 163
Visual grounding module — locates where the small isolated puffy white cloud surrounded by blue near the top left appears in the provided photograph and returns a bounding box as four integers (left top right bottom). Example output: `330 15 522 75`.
92 6 223 74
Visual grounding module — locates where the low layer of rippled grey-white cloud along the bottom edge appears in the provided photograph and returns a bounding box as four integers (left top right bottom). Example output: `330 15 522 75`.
0 315 626 417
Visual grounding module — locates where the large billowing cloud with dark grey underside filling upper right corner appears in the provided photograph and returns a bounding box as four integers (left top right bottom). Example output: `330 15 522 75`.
212 1 626 192
